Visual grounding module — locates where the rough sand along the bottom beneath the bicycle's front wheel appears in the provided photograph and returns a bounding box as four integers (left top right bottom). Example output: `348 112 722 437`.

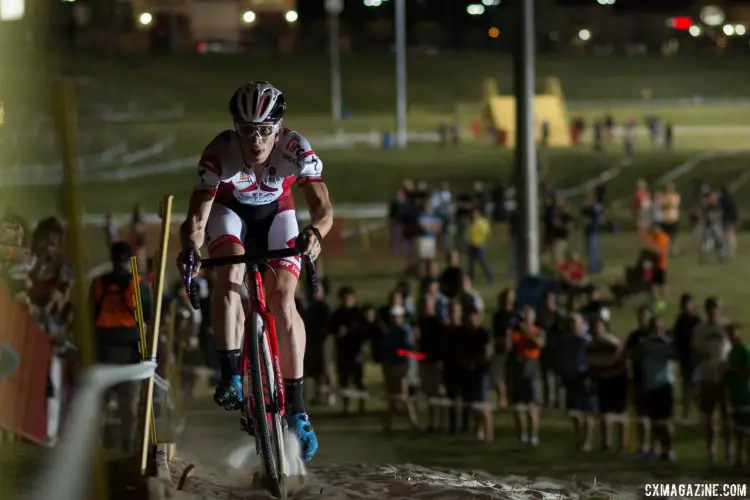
172 458 639 500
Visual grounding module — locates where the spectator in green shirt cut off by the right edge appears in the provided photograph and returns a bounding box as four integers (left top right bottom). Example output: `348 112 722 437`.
724 323 750 467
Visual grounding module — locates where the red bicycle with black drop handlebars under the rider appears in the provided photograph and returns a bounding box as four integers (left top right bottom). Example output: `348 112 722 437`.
185 248 316 497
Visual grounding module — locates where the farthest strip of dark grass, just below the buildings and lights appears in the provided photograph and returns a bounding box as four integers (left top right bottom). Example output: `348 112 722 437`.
55 53 748 115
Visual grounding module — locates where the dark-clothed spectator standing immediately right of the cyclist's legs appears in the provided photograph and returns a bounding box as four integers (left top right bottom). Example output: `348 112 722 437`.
304 283 332 404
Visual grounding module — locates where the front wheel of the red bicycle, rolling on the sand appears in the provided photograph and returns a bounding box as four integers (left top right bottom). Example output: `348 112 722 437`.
246 313 286 497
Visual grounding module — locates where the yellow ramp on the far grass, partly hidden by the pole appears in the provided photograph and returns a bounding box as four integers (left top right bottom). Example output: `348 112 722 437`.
485 75 572 148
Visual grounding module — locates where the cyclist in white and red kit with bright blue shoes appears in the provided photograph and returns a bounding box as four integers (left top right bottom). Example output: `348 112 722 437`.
179 81 333 461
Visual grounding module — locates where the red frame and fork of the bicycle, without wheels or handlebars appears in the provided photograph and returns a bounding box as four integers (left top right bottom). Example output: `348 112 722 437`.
240 264 286 417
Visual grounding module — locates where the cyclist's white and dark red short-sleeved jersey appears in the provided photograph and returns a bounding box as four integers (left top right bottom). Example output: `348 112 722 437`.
195 128 323 211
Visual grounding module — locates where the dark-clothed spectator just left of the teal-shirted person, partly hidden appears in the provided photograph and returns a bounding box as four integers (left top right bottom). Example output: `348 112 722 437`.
625 305 654 457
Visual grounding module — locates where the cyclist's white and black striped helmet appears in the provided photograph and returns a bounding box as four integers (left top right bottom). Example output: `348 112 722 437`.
229 81 286 123
